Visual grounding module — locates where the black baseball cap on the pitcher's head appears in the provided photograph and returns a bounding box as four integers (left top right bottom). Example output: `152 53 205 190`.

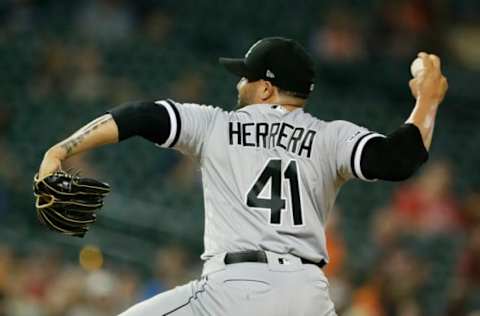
219 37 315 98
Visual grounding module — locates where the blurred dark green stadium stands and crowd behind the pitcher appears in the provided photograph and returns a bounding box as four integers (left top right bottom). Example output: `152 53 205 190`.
0 0 480 316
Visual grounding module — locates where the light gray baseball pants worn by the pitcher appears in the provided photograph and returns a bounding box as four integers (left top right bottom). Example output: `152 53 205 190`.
120 252 336 316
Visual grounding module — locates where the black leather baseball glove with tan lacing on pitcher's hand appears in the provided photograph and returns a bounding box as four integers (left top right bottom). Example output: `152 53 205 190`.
33 171 110 237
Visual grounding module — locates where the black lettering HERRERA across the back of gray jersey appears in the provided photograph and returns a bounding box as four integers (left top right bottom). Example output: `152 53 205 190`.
228 122 317 158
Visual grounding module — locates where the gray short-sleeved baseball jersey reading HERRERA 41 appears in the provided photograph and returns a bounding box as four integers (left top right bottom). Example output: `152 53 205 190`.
156 100 382 262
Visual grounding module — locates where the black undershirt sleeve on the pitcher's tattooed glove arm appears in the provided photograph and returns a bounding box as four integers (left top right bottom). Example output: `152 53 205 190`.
108 102 171 145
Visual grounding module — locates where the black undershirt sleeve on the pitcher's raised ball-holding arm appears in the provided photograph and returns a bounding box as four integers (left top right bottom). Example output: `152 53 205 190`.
360 124 428 181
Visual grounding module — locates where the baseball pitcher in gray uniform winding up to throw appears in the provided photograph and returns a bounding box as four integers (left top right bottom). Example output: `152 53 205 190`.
35 37 447 316
